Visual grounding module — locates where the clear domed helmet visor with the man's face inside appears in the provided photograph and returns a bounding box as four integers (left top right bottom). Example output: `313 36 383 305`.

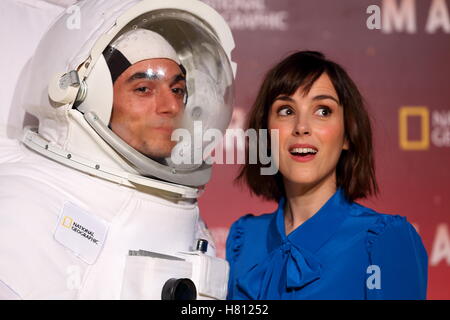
105 9 234 169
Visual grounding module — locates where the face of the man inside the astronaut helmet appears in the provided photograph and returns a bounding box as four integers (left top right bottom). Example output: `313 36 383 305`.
110 59 186 158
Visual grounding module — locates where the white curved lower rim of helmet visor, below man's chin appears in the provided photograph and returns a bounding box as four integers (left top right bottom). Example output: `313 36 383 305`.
84 111 212 187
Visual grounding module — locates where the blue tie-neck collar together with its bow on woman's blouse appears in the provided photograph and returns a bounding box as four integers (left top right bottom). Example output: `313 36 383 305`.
237 189 351 299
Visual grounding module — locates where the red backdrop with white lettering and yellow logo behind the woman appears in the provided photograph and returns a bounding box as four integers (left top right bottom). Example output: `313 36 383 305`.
200 0 450 299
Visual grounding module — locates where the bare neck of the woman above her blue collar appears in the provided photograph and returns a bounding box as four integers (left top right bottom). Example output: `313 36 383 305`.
284 174 336 235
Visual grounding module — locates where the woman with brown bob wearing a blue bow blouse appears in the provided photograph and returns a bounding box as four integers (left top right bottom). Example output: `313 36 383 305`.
227 51 427 299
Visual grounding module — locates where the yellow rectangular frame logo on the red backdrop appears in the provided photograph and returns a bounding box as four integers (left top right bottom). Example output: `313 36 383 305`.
398 107 430 150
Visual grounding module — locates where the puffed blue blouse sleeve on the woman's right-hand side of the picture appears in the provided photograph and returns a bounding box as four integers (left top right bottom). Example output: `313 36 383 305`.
366 215 428 300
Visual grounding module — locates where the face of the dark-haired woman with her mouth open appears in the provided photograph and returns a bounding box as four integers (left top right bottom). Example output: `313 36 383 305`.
268 73 348 187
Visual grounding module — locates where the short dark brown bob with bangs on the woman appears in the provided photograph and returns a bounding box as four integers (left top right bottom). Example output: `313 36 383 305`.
236 51 378 202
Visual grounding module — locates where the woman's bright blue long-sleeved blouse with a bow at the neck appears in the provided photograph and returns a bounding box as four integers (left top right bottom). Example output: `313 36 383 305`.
226 189 428 300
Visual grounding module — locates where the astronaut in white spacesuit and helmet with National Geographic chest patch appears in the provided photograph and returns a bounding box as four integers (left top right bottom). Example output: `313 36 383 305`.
0 0 235 299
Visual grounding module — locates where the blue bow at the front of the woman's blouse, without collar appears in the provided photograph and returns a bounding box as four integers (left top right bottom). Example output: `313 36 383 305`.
237 240 320 300
